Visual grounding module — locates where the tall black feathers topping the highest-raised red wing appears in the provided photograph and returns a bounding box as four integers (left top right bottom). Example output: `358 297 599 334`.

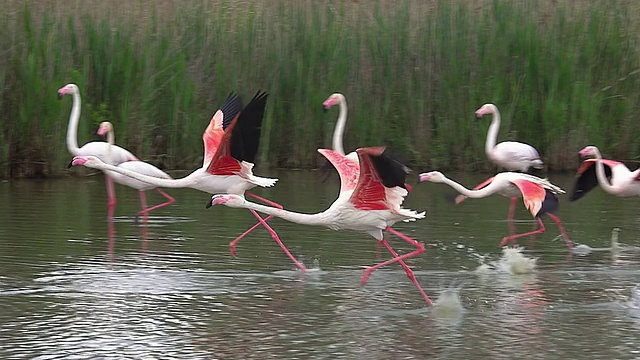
230 91 269 163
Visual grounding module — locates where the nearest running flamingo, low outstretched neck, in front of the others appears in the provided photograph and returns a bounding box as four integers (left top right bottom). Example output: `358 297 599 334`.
208 147 431 305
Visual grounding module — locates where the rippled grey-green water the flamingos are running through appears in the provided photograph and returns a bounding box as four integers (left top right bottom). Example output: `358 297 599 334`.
0 171 640 359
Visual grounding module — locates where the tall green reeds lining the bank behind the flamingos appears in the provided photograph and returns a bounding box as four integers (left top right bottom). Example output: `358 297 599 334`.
0 0 640 176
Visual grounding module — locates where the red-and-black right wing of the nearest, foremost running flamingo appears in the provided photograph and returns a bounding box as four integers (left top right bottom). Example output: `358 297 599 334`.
349 147 409 210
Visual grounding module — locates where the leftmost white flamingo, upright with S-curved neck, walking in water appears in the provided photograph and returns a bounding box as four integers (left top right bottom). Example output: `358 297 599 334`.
58 84 138 211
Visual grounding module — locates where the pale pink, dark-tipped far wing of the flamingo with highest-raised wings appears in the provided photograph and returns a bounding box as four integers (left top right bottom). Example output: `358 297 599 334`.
202 93 242 167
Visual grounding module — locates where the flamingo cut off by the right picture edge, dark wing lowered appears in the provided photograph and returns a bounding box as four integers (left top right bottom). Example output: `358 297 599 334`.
569 146 640 201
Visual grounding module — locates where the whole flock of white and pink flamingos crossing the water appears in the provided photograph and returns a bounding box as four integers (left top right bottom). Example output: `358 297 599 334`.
58 84 640 304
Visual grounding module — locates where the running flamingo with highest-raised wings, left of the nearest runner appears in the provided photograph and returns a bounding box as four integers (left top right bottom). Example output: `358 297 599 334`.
72 92 307 272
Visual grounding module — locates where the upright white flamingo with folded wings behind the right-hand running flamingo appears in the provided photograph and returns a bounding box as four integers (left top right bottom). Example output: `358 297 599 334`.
455 104 544 234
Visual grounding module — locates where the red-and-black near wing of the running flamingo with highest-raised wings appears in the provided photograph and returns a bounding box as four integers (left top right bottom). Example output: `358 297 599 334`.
207 92 268 175
